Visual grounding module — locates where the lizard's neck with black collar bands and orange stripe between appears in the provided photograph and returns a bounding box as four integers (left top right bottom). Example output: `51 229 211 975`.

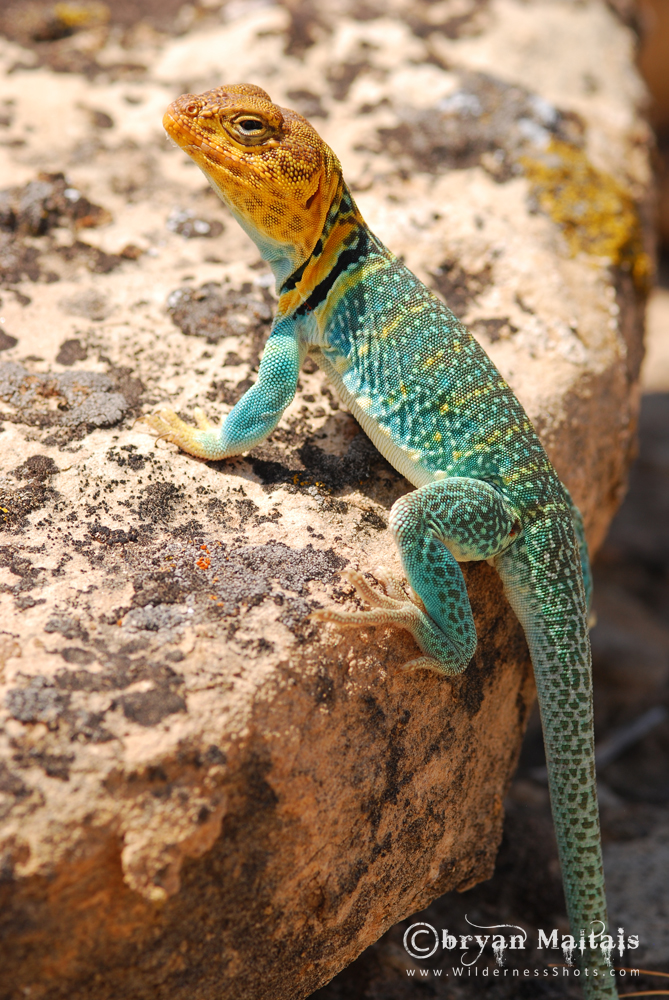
278 178 376 315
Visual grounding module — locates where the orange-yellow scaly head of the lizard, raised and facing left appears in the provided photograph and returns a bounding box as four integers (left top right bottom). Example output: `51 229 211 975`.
163 83 341 280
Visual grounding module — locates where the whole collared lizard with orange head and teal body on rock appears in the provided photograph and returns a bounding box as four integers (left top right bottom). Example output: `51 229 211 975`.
145 84 617 1000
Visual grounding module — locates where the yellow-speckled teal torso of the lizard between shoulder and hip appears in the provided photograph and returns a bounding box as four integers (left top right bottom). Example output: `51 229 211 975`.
323 250 552 488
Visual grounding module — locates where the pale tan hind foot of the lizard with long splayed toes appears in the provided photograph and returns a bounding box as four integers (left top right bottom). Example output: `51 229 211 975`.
310 568 452 674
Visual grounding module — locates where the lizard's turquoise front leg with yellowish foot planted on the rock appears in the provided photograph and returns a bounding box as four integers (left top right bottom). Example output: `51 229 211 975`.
142 319 305 460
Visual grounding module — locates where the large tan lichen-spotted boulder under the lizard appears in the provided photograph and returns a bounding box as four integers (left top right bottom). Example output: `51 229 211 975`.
0 0 649 1000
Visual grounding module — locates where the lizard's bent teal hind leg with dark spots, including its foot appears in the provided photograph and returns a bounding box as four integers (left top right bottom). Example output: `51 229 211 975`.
312 477 520 674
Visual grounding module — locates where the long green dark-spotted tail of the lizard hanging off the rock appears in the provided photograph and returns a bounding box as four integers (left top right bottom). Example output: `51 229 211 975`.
495 511 618 1000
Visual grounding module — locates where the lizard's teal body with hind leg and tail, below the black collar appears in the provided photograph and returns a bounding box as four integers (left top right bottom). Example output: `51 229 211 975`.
305 191 617 998
